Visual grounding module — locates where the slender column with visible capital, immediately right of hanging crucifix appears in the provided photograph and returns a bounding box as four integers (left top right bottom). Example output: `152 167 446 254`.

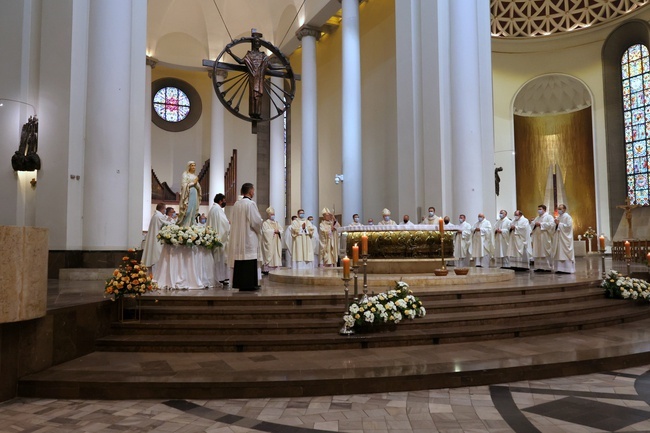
296 27 320 218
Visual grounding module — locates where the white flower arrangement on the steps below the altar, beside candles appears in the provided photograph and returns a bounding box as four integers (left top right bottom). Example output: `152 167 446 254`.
343 281 427 329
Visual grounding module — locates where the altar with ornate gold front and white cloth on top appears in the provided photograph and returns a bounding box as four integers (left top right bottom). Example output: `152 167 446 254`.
338 225 456 259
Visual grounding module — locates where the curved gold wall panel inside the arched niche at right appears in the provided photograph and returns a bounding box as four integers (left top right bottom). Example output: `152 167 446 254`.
514 108 597 238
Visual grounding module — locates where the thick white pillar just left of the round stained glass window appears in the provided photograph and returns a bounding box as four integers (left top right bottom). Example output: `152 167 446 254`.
83 0 147 249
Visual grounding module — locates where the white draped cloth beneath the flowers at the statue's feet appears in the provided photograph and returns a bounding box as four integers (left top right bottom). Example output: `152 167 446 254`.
153 244 216 289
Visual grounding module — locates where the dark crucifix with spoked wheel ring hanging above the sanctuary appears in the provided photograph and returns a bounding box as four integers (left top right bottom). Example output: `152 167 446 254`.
203 29 296 133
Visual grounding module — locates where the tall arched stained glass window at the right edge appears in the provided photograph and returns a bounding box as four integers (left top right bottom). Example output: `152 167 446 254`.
621 44 650 206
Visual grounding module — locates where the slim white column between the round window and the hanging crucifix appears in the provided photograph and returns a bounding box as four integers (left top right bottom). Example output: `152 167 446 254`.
208 71 226 205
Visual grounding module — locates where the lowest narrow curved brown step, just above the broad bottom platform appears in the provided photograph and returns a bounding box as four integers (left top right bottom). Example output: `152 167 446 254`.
96 302 648 352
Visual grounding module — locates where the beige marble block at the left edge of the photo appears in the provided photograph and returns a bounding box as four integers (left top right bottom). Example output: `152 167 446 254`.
0 226 48 323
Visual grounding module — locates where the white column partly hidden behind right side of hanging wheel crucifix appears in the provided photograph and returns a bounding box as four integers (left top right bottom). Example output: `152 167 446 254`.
269 77 287 224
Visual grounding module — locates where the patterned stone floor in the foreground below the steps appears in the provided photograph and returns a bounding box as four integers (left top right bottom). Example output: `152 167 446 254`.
0 366 650 433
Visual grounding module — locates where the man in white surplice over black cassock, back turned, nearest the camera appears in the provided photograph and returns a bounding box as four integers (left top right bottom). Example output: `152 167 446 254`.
228 183 262 291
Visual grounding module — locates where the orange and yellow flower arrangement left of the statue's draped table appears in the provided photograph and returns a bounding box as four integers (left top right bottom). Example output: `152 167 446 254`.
104 249 158 300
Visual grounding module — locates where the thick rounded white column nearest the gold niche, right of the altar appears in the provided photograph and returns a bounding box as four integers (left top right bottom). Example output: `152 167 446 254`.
448 0 495 222
